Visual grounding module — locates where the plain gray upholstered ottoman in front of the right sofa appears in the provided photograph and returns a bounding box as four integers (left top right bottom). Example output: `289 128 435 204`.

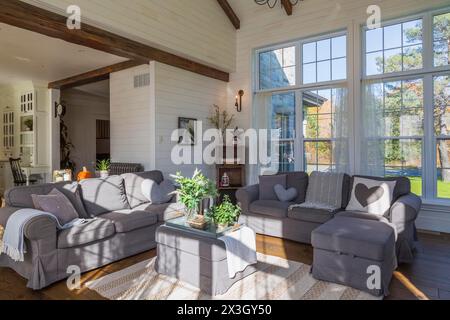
312 217 397 296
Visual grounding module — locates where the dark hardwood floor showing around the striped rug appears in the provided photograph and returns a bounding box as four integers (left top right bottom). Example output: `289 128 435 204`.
0 234 450 300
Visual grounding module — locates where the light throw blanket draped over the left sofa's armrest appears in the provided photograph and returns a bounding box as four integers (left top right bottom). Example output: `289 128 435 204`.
0 209 86 262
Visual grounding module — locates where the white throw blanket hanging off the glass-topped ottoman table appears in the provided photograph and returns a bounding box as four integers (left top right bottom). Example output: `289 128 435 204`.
219 227 258 279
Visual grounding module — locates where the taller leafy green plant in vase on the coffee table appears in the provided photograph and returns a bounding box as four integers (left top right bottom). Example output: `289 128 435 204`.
172 170 217 221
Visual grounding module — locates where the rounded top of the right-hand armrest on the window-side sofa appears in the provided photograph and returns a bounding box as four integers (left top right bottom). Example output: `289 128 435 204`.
389 193 422 226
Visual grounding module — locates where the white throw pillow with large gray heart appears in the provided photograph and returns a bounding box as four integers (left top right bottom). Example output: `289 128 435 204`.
346 178 396 216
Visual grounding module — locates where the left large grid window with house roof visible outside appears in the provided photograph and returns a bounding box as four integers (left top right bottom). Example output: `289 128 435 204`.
255 32 348 172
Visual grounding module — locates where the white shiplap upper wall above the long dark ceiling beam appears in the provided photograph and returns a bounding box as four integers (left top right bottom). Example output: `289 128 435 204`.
24 0 236 71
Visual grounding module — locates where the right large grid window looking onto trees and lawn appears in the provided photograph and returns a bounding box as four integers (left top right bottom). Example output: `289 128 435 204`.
361 9 450 199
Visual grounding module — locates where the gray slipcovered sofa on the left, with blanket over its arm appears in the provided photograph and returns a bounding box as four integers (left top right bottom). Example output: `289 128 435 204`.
0 171 182 290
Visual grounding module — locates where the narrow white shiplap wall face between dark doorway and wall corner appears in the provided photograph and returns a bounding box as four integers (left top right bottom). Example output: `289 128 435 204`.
110 65 154 170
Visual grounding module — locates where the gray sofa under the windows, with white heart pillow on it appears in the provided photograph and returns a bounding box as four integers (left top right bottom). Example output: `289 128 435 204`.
236 172 422 263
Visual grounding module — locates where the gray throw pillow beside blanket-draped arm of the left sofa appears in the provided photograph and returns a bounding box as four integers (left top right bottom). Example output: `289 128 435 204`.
31 189 79 226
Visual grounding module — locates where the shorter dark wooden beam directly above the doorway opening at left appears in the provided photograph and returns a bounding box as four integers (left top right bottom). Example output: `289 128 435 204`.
48 60 143 89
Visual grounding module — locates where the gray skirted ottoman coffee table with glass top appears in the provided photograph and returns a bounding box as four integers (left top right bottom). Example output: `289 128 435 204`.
155 217 257 296
